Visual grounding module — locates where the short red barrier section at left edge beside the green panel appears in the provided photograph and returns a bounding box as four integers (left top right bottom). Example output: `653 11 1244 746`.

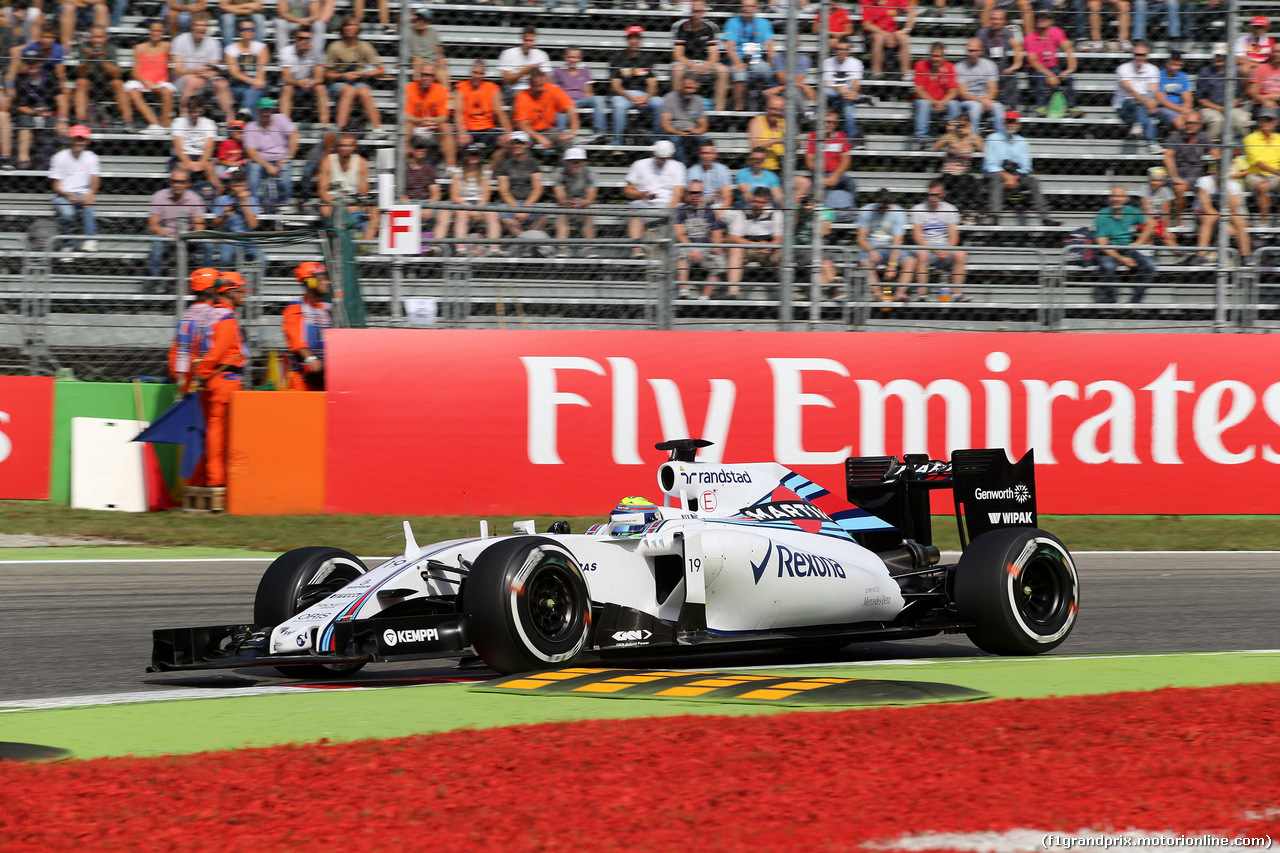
0 377 54 501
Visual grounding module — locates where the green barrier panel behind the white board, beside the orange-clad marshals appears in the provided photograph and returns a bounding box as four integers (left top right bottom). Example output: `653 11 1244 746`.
49 379 178 503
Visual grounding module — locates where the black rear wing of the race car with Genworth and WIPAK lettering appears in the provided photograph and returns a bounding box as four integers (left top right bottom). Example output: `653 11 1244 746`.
845 448 1038 548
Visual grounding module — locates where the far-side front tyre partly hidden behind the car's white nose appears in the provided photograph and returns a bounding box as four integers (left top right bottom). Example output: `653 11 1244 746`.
253 546 367 679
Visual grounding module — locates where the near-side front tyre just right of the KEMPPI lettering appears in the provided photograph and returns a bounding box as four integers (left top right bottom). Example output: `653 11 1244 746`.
465 537 591 674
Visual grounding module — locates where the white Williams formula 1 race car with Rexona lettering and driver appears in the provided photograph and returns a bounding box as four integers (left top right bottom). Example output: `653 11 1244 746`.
150 439 1079 678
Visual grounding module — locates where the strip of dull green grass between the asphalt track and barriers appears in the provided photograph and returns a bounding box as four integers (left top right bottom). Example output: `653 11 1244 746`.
0 501 1280 556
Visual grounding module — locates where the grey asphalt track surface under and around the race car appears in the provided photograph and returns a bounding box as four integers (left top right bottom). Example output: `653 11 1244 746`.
0 552 1280 699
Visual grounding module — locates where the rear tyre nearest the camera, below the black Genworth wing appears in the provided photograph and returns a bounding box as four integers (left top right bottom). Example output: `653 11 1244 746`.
955 528 1080 654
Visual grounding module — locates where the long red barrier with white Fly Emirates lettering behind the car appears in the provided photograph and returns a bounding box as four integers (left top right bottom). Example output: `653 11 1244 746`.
326 329 1280 515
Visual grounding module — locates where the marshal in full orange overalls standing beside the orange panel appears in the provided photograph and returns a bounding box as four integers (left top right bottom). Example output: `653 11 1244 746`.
196 273 248 488
